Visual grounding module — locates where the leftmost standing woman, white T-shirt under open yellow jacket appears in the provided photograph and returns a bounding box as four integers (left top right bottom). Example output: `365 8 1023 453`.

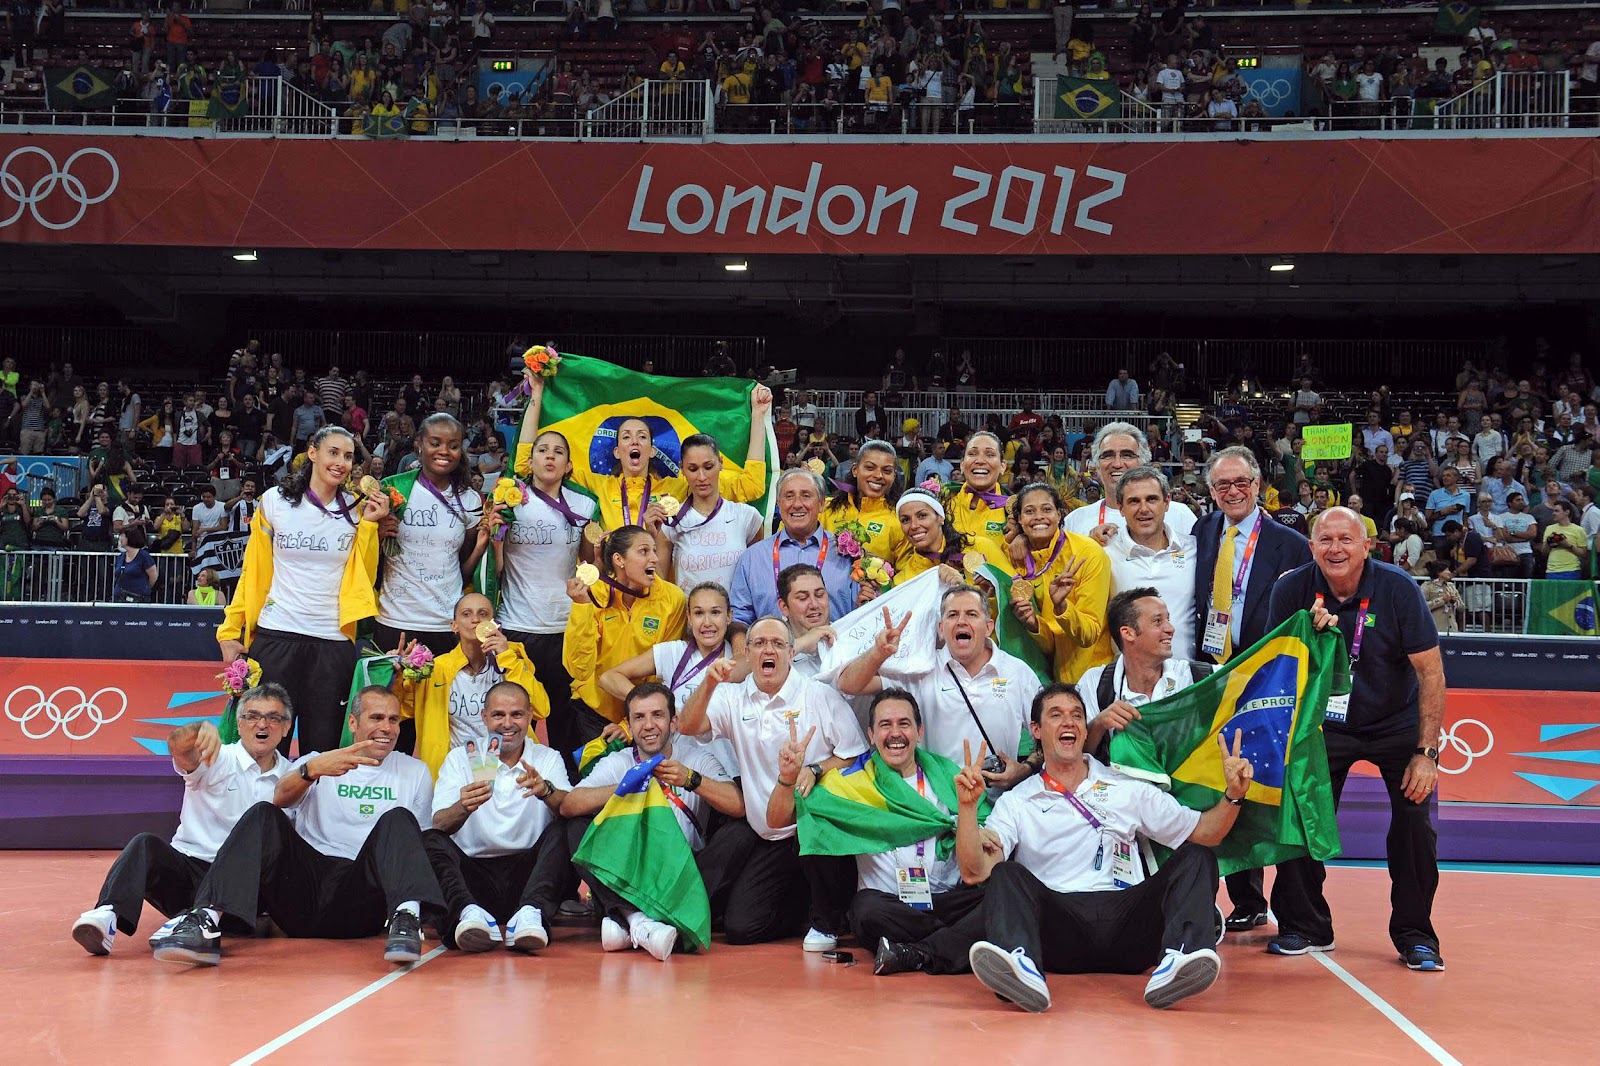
216 426 389 752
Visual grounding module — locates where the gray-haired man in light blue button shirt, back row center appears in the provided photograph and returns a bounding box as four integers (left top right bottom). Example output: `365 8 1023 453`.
728 469 859 626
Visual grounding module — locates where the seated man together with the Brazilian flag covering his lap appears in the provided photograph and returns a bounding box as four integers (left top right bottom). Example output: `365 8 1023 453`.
562 680 744 962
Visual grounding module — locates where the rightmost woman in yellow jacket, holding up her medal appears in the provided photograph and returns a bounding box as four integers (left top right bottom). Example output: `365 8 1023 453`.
1008 482 1115 683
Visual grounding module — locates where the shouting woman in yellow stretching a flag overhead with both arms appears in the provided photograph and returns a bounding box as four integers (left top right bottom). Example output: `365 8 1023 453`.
515 368 773 530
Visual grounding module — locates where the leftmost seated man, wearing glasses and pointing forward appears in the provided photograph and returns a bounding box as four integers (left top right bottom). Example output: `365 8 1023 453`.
72 682 294 956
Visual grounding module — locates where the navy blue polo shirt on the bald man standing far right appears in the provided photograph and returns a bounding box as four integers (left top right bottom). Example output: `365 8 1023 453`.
1267 559 1438 738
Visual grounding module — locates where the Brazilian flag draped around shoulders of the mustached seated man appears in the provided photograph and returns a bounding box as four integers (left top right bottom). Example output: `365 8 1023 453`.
795 747 989 860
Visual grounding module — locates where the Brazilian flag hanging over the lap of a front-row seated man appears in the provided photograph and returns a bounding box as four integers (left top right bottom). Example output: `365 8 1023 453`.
573 775 710 951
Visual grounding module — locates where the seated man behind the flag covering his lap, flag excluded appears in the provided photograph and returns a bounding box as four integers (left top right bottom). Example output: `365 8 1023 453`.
562 682 744 962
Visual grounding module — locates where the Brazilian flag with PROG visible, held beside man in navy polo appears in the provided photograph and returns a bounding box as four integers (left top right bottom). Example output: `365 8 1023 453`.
1110 611 1350 874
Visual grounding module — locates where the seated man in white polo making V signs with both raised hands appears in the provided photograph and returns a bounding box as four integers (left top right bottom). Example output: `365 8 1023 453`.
955 683 1253 1012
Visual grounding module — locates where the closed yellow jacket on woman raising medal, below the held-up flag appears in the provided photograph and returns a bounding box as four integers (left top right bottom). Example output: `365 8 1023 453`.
562 578 688 722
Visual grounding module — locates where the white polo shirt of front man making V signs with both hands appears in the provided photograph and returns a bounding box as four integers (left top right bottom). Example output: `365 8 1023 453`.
986 755 1200 892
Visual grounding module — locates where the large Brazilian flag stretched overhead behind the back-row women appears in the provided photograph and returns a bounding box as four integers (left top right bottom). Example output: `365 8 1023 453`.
524 354 781 517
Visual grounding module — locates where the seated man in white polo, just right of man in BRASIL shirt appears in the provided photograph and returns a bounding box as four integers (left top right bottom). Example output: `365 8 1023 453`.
422 680 578 952
